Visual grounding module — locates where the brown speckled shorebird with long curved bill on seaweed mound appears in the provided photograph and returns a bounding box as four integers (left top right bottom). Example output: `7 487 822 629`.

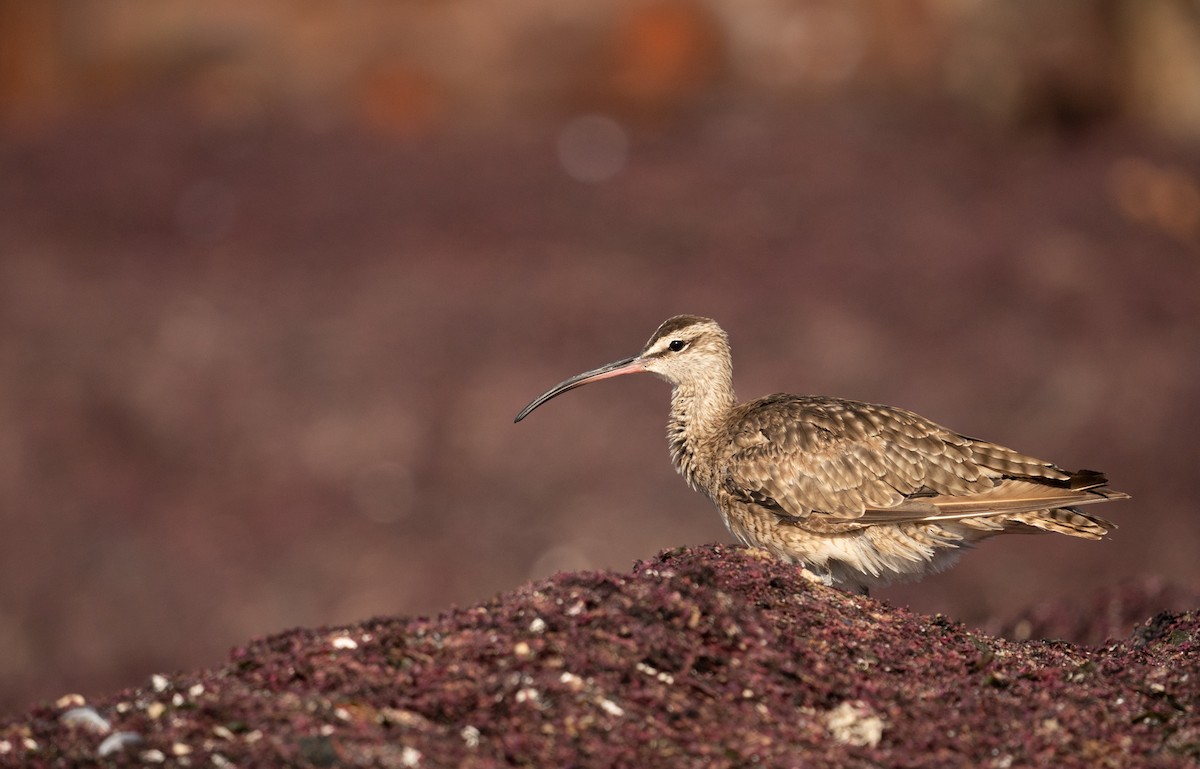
514 316 1129 593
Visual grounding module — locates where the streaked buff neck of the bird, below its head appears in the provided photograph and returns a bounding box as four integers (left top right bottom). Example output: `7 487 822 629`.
667 372 737 495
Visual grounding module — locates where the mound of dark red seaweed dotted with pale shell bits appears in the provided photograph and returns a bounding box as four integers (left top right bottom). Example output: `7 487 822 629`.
0 546 1200 769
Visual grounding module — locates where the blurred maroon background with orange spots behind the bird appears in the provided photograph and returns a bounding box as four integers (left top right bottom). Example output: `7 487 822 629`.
0 0 1200 710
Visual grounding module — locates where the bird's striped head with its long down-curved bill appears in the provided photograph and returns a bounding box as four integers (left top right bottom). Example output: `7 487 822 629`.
514 316 732 422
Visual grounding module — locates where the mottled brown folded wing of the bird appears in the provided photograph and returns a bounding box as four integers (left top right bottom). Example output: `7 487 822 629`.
725 395 1070 522
